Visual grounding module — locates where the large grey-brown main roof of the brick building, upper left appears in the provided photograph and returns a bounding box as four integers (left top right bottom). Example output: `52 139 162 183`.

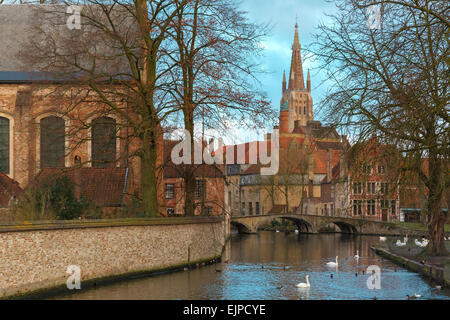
0 4 137 76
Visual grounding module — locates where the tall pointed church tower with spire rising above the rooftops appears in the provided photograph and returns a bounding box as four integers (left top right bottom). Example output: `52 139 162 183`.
280 24 314 133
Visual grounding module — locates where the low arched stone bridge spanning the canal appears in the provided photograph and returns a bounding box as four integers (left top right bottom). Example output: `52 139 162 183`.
231 213 401 234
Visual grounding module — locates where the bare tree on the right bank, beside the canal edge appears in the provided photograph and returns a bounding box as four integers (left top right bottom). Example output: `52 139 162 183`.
313 0 450 255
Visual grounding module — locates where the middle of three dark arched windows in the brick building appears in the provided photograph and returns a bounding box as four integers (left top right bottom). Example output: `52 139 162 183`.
40 116 66 168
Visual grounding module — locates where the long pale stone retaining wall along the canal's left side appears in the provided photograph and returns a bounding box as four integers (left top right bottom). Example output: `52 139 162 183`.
0 218 228 298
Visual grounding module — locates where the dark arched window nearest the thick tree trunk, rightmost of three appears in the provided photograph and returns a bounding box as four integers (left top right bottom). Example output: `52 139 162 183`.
92 117 116 168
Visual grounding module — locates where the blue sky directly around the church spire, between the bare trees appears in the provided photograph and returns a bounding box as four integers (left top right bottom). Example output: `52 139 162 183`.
242 0 336 127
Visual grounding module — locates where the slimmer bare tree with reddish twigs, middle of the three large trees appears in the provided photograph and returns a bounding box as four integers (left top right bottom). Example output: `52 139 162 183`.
166 0 274 215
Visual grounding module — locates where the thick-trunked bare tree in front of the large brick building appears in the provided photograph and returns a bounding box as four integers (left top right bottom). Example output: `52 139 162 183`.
22 0 187 216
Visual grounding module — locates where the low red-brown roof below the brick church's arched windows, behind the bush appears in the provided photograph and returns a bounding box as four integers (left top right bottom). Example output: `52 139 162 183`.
31 167 130 207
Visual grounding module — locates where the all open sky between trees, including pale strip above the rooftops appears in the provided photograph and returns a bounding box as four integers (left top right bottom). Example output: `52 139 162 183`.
175 0 337 145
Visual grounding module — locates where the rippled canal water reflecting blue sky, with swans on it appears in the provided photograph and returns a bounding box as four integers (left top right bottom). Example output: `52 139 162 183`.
55 231 450 300
